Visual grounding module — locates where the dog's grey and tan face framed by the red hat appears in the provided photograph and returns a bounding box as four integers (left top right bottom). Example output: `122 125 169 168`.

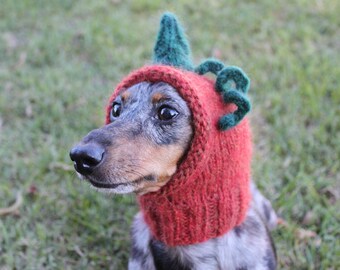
70 82 193 194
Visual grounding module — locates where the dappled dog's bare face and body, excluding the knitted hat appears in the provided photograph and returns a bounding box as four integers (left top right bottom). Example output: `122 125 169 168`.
70 82 277 270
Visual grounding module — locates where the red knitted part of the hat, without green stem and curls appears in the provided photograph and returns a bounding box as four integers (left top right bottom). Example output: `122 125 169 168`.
106 65 251 246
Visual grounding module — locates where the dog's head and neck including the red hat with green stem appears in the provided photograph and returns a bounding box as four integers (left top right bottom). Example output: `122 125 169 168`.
70 13 255 245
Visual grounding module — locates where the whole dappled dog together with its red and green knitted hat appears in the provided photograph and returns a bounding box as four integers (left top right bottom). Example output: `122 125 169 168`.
70 14 277 270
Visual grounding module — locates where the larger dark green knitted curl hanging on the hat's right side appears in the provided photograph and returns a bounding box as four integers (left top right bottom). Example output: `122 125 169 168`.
215 67 251 130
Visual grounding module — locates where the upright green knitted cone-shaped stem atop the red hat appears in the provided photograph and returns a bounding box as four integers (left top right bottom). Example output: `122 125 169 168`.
153 12 194 71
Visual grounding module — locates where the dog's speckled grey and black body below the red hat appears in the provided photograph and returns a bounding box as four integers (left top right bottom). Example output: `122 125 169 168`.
129 183 277 270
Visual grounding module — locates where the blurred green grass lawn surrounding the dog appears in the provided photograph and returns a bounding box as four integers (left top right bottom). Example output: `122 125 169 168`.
0 0 340 270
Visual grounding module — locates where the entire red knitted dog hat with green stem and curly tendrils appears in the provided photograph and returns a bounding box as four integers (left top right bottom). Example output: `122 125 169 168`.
106 13 251 246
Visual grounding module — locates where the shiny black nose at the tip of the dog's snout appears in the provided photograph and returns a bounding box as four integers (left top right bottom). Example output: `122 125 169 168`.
70 144 105 175
